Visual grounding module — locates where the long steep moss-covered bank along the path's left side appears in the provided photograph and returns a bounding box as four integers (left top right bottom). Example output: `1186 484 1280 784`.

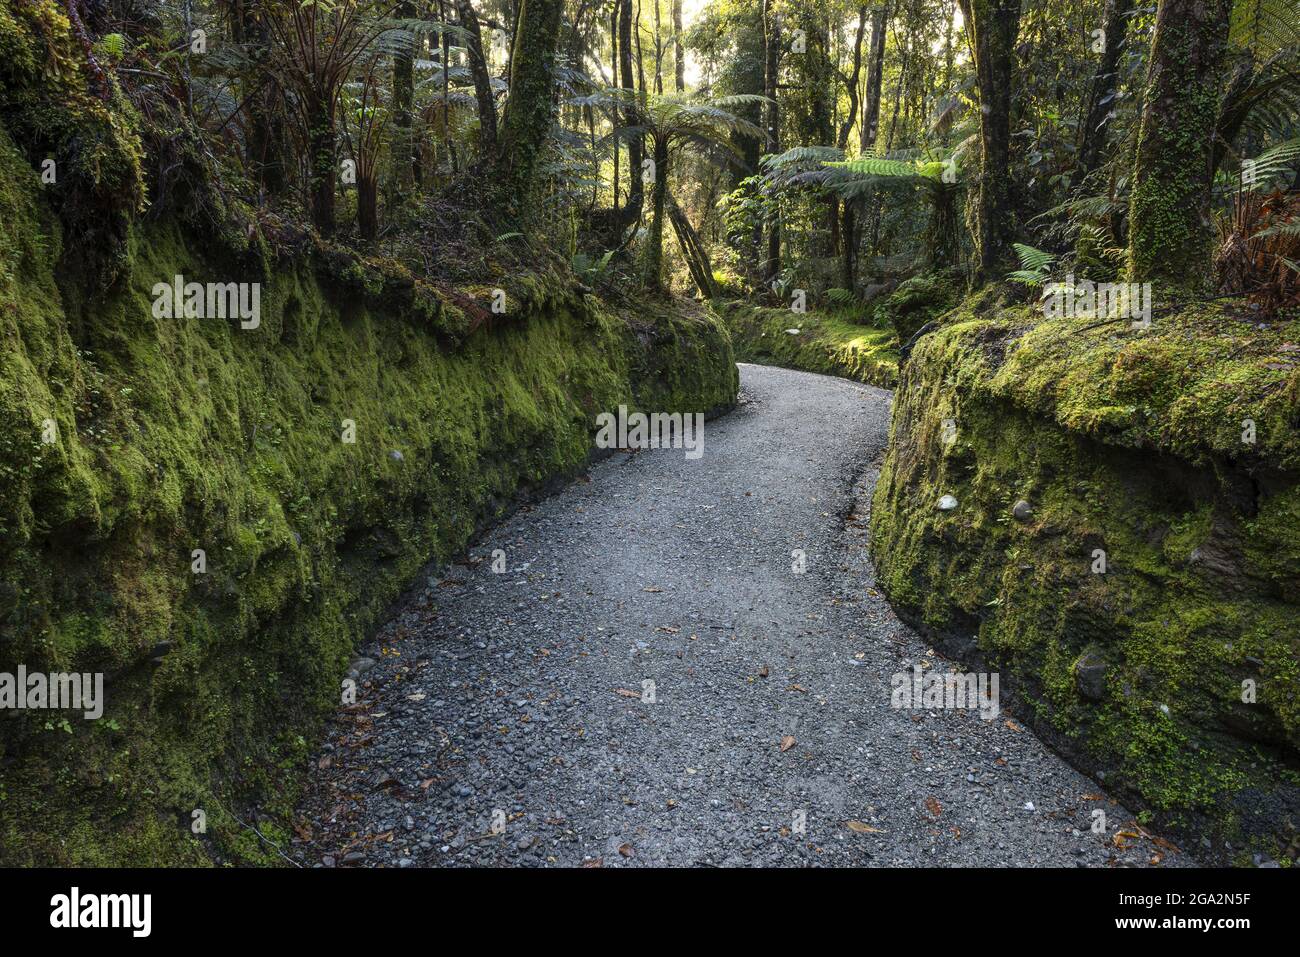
0 117 737 865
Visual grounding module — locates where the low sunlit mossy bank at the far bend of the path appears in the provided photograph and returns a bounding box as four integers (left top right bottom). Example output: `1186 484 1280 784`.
718 302 898 387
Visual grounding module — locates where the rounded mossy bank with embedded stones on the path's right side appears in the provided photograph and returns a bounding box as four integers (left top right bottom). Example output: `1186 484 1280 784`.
871 296 1300 863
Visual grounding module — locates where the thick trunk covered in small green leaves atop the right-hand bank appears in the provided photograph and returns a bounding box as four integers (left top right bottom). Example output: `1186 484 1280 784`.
1128 0 1232 289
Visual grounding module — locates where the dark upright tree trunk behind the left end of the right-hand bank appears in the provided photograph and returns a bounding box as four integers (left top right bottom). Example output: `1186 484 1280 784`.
961 0 1021 282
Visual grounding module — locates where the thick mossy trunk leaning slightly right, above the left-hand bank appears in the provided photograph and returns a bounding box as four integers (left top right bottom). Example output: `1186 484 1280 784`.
497 0 564 215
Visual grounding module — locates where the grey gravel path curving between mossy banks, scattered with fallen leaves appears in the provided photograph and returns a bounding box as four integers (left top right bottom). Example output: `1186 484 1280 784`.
290 365 1191 867
